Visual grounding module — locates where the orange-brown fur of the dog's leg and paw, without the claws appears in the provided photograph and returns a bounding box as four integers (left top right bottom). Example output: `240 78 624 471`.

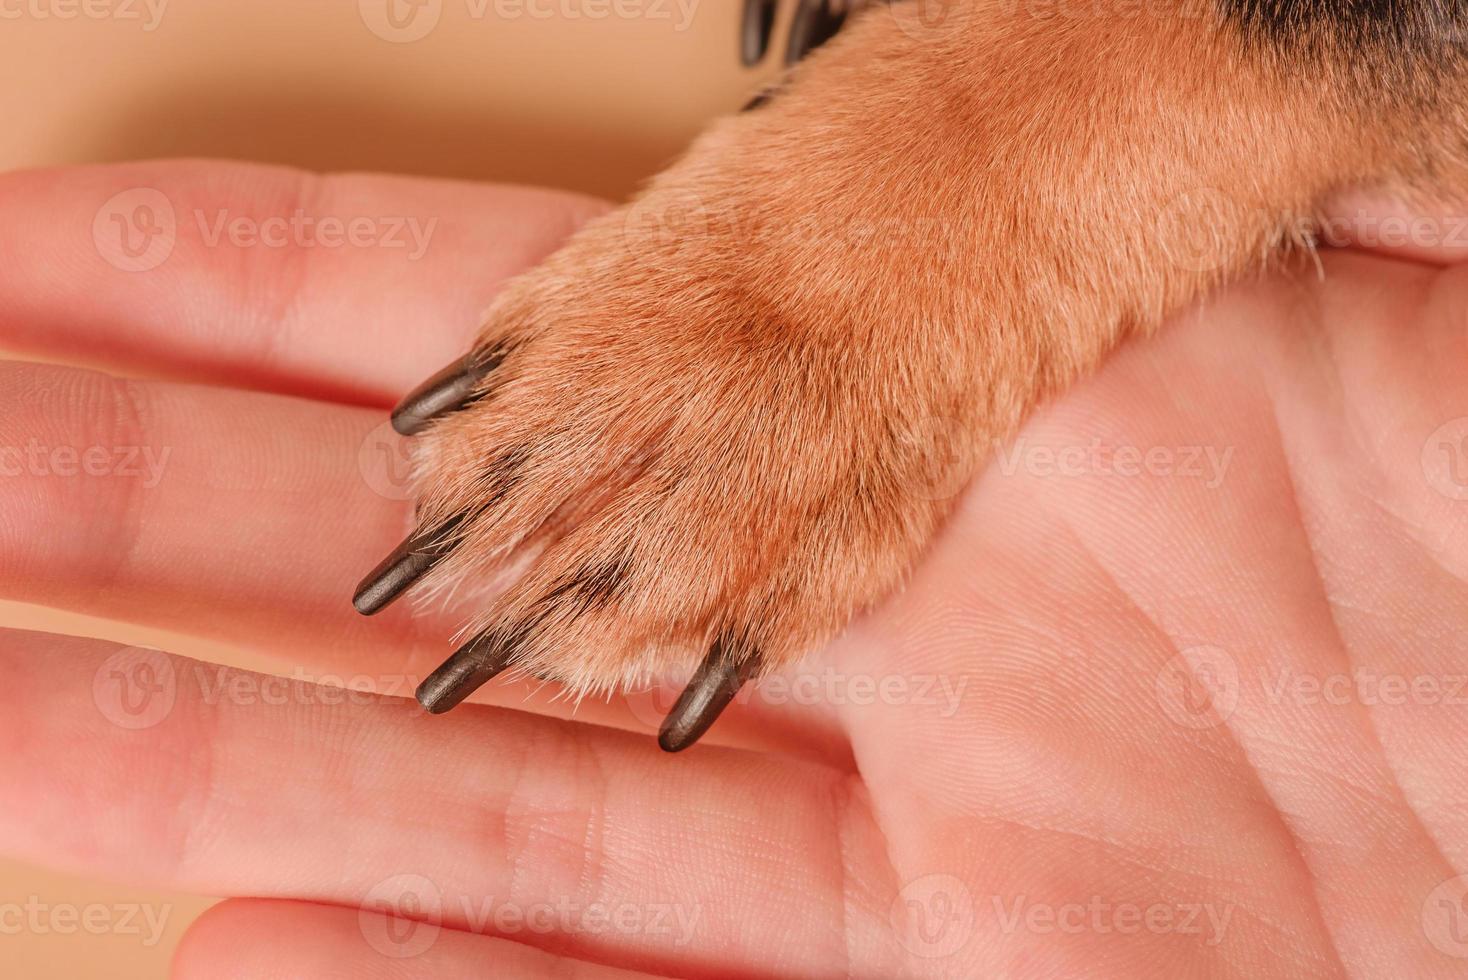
405 0 1465 692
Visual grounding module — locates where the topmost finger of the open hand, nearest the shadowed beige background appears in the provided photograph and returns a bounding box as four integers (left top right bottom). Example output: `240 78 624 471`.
0 161 605 405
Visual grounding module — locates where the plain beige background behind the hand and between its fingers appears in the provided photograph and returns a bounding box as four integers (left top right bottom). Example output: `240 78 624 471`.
0 0 788 980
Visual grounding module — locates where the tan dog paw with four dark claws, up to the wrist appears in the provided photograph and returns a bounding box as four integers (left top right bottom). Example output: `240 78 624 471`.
357 160 966 750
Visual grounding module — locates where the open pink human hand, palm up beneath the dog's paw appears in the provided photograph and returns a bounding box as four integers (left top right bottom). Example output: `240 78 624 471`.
0 163 1468 980
